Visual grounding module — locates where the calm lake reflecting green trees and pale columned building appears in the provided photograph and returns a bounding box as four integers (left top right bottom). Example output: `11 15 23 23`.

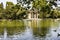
0 19 60 40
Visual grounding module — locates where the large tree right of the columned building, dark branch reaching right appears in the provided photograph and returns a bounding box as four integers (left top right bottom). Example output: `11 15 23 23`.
33 0 57 18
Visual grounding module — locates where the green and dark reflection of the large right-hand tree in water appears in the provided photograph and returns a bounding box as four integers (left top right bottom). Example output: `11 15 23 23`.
32 19 51 37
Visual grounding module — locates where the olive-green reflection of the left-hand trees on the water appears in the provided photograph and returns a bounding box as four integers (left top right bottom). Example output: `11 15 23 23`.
0 20 25 36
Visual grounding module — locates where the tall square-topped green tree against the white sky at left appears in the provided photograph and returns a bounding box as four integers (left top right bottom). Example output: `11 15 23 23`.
4 2 20 19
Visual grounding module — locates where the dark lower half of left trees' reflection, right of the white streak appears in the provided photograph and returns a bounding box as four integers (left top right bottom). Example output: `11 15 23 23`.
7 27 25 35
